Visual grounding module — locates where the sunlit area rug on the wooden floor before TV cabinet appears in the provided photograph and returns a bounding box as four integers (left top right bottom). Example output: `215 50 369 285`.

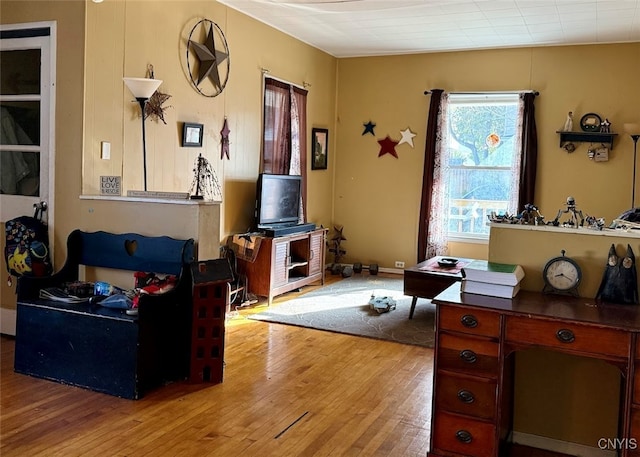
249 274 435 348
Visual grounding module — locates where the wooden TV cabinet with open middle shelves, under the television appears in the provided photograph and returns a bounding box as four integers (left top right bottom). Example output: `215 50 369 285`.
238 228 327 305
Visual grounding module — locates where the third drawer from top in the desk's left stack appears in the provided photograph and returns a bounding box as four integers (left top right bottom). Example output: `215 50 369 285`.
435 373 498 419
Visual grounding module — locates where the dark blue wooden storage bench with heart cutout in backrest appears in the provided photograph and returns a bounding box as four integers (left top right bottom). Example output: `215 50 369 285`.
14 230 195 399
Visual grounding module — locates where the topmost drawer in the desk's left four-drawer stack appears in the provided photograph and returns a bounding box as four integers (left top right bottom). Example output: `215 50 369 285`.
438 305 500 338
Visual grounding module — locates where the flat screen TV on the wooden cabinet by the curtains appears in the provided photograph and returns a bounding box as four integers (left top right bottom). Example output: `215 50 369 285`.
256 173 302 229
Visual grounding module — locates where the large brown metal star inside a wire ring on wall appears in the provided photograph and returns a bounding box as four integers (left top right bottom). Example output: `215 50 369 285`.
187 19 231 97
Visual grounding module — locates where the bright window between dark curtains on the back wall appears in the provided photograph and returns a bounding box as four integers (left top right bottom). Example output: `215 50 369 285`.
440 93 522 241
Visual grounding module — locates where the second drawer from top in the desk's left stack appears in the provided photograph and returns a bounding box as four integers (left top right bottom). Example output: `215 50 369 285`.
437 333 499 378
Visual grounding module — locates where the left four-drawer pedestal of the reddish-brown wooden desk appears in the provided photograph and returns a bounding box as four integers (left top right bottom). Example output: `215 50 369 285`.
431 306 501 457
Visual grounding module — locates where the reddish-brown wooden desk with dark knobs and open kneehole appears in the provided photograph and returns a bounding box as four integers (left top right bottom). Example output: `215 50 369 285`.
428 284 640 457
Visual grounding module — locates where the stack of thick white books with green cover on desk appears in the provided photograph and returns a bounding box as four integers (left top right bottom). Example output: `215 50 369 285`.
460 260 524 298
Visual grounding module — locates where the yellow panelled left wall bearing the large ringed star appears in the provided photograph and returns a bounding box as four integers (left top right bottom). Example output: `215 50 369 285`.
83 0 336 237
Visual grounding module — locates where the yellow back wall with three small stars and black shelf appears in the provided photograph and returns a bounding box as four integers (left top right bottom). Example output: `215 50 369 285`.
340 43 640 266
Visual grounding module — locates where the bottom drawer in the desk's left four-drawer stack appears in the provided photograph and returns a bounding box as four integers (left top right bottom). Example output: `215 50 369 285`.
431 410 496 457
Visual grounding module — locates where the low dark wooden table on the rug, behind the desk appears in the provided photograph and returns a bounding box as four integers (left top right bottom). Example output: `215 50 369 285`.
404 256 474 319
